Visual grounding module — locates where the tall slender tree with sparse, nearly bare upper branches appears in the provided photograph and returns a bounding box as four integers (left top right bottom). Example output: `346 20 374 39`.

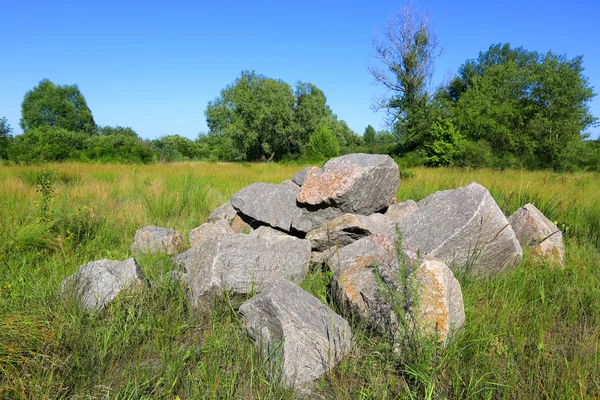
368 3 439 147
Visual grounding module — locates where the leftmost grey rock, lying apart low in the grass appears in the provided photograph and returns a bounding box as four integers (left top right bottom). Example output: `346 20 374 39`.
60 258 144 311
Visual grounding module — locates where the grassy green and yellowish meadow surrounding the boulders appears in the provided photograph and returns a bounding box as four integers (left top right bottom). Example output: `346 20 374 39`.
0 163 600 399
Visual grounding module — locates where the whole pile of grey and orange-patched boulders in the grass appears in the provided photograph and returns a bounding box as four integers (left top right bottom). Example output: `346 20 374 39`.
58 154 564 394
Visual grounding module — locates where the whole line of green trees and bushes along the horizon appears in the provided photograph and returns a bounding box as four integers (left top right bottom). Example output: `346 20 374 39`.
0 41 600 171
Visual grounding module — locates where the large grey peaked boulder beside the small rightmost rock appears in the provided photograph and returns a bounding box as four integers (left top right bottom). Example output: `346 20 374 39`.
398 183 523 273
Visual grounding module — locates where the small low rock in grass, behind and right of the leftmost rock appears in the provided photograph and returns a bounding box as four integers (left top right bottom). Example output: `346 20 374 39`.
131 226 184 254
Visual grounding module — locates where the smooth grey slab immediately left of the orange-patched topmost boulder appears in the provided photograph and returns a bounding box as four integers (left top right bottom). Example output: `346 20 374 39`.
231 182 302 232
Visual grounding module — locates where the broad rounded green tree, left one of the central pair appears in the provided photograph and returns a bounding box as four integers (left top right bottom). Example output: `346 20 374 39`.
205 71 298 161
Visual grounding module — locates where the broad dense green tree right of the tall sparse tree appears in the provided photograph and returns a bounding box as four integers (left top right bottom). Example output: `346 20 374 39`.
443 44 596 169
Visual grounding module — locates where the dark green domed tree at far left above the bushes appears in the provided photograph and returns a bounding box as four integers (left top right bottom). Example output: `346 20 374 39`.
20 79 96 135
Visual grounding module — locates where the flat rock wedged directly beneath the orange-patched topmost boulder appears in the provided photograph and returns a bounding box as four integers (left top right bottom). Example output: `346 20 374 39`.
306 214 393 251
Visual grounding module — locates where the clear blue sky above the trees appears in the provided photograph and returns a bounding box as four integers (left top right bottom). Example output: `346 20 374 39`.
0 0 600 139
